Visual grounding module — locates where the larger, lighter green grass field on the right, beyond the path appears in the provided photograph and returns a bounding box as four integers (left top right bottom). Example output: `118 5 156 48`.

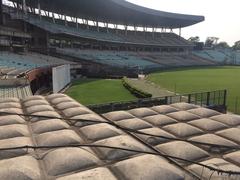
148 66 240 114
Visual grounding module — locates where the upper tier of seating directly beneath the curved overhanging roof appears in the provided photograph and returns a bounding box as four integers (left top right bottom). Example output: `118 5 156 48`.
11 14 189 46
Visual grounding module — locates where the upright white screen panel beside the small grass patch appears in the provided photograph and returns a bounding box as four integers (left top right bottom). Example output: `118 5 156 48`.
52 64 71 93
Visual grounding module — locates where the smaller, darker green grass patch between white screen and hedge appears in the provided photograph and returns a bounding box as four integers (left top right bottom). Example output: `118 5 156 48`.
66 79 136 105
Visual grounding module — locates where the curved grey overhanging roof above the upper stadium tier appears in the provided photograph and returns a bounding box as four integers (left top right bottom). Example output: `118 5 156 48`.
11 0 204 28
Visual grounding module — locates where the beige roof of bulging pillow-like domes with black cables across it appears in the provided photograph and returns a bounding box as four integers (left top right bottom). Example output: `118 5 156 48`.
0 94 240 180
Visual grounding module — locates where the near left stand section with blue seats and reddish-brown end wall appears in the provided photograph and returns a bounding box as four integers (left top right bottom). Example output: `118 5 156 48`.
0 51 75 99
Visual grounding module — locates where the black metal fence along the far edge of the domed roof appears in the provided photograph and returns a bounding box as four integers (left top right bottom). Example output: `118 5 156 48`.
88 90 227 113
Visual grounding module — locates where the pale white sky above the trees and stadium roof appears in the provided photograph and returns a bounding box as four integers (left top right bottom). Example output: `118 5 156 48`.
128 0 240 45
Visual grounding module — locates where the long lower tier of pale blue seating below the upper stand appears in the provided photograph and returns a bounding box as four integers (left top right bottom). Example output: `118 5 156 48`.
57 48 214 69
